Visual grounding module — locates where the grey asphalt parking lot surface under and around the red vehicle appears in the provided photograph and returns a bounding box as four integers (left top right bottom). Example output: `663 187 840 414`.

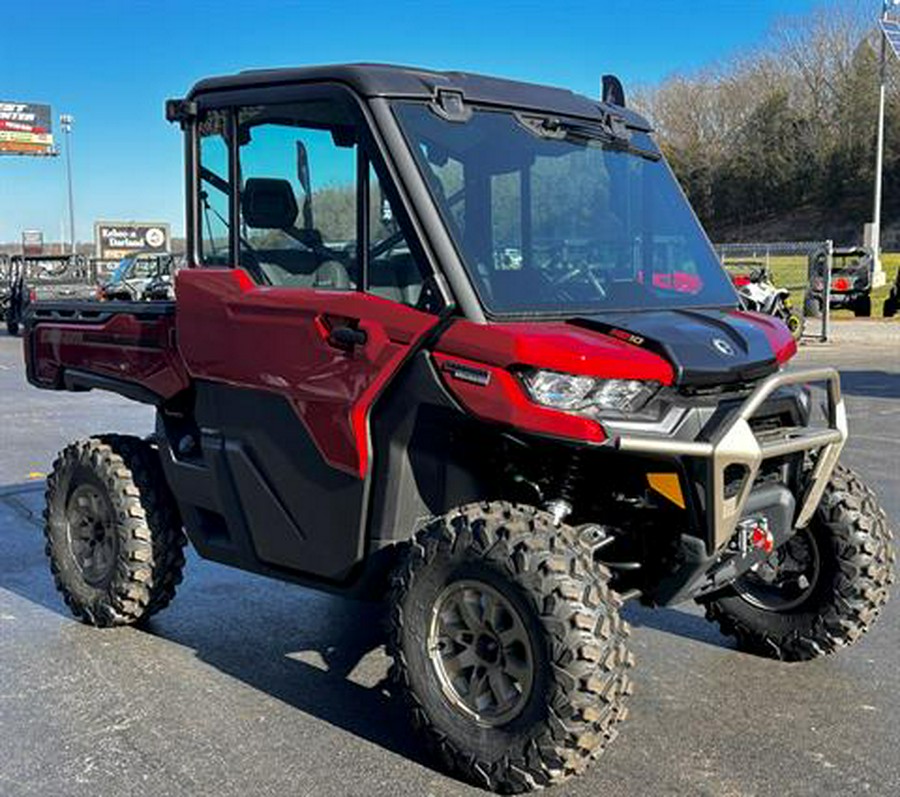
0 322 900 797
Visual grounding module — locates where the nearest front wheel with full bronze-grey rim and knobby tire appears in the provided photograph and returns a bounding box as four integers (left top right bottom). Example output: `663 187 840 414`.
389 502 632 793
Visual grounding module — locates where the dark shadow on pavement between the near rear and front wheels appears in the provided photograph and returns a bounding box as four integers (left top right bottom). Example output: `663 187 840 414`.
144 584 432 769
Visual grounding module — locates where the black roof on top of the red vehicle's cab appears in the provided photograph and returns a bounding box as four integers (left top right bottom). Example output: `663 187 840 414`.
188 64 650 129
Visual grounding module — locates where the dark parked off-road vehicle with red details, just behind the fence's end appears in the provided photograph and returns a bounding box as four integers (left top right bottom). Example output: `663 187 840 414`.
804 246 875 318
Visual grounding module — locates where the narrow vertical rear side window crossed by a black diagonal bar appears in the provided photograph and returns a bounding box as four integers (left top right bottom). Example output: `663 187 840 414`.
198 111 231 266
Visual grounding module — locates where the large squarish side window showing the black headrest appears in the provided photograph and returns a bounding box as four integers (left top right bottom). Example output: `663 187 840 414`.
238 101 358 290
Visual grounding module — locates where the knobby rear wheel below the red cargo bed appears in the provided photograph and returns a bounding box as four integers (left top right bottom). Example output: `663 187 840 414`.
44 435 186 626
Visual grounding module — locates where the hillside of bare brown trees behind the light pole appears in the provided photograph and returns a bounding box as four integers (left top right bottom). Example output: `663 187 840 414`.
636 0 900 248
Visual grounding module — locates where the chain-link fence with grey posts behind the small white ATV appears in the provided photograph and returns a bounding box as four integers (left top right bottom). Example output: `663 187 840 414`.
715 241 834 342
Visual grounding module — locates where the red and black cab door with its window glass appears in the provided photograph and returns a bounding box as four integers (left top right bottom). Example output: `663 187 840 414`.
176 91 438 581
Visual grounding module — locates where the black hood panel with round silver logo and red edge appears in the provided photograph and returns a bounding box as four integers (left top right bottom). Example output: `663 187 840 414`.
570 310 796 387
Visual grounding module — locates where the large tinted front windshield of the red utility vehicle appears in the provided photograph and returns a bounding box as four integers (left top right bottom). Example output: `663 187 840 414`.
394 102 737 315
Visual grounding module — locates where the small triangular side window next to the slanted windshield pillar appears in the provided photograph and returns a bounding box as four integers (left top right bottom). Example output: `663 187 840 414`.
368 166 437 311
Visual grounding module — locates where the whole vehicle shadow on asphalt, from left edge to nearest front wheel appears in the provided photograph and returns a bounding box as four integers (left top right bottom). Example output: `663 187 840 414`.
0 483 431 768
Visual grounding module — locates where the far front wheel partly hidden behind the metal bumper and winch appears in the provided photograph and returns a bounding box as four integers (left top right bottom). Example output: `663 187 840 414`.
706 465 894 661
